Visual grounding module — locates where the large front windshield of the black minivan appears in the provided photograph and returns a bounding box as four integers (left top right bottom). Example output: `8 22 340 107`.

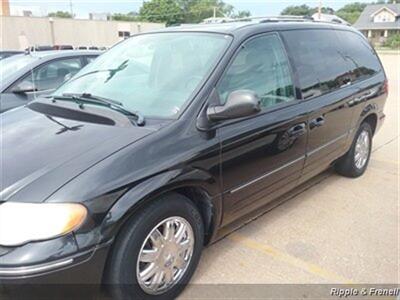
54 32 231 118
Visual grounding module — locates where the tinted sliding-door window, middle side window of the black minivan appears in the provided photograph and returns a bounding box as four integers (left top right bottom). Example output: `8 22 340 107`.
282 29 351 99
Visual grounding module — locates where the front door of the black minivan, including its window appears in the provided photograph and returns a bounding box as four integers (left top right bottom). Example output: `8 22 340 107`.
217 34 307 225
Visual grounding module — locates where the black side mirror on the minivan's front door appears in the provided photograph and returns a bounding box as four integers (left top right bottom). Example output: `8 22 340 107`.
207 90 261 121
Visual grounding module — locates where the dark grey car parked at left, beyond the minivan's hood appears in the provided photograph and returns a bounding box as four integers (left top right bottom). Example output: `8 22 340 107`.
0 51 101 113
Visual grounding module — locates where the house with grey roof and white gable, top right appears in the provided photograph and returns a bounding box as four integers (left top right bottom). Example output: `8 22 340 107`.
354 4 400 46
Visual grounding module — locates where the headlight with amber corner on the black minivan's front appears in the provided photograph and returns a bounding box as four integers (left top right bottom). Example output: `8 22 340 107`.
0 202 87 246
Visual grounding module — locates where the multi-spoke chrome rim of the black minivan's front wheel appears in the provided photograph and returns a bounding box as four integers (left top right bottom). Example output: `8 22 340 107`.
136 217 194 295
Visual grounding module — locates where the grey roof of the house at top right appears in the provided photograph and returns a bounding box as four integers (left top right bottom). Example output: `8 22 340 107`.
354 4 400 30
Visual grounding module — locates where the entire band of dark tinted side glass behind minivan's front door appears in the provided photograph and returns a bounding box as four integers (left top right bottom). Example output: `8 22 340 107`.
282 29 381 99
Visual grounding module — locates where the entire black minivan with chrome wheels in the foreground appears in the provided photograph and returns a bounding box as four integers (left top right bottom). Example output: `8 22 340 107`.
0 19 388 299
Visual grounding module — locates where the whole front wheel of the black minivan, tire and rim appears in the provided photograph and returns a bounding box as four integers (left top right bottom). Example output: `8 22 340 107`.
105 193 204 300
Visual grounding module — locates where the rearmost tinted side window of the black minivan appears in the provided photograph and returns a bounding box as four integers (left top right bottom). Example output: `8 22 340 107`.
336 31 382 81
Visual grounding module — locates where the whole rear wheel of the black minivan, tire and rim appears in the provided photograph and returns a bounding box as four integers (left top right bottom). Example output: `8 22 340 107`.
335 122 372 178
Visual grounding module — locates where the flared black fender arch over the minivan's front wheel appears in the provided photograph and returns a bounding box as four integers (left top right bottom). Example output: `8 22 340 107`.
66 168 222 250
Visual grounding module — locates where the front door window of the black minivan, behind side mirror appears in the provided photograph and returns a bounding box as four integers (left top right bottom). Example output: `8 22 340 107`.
217 34 295 108
